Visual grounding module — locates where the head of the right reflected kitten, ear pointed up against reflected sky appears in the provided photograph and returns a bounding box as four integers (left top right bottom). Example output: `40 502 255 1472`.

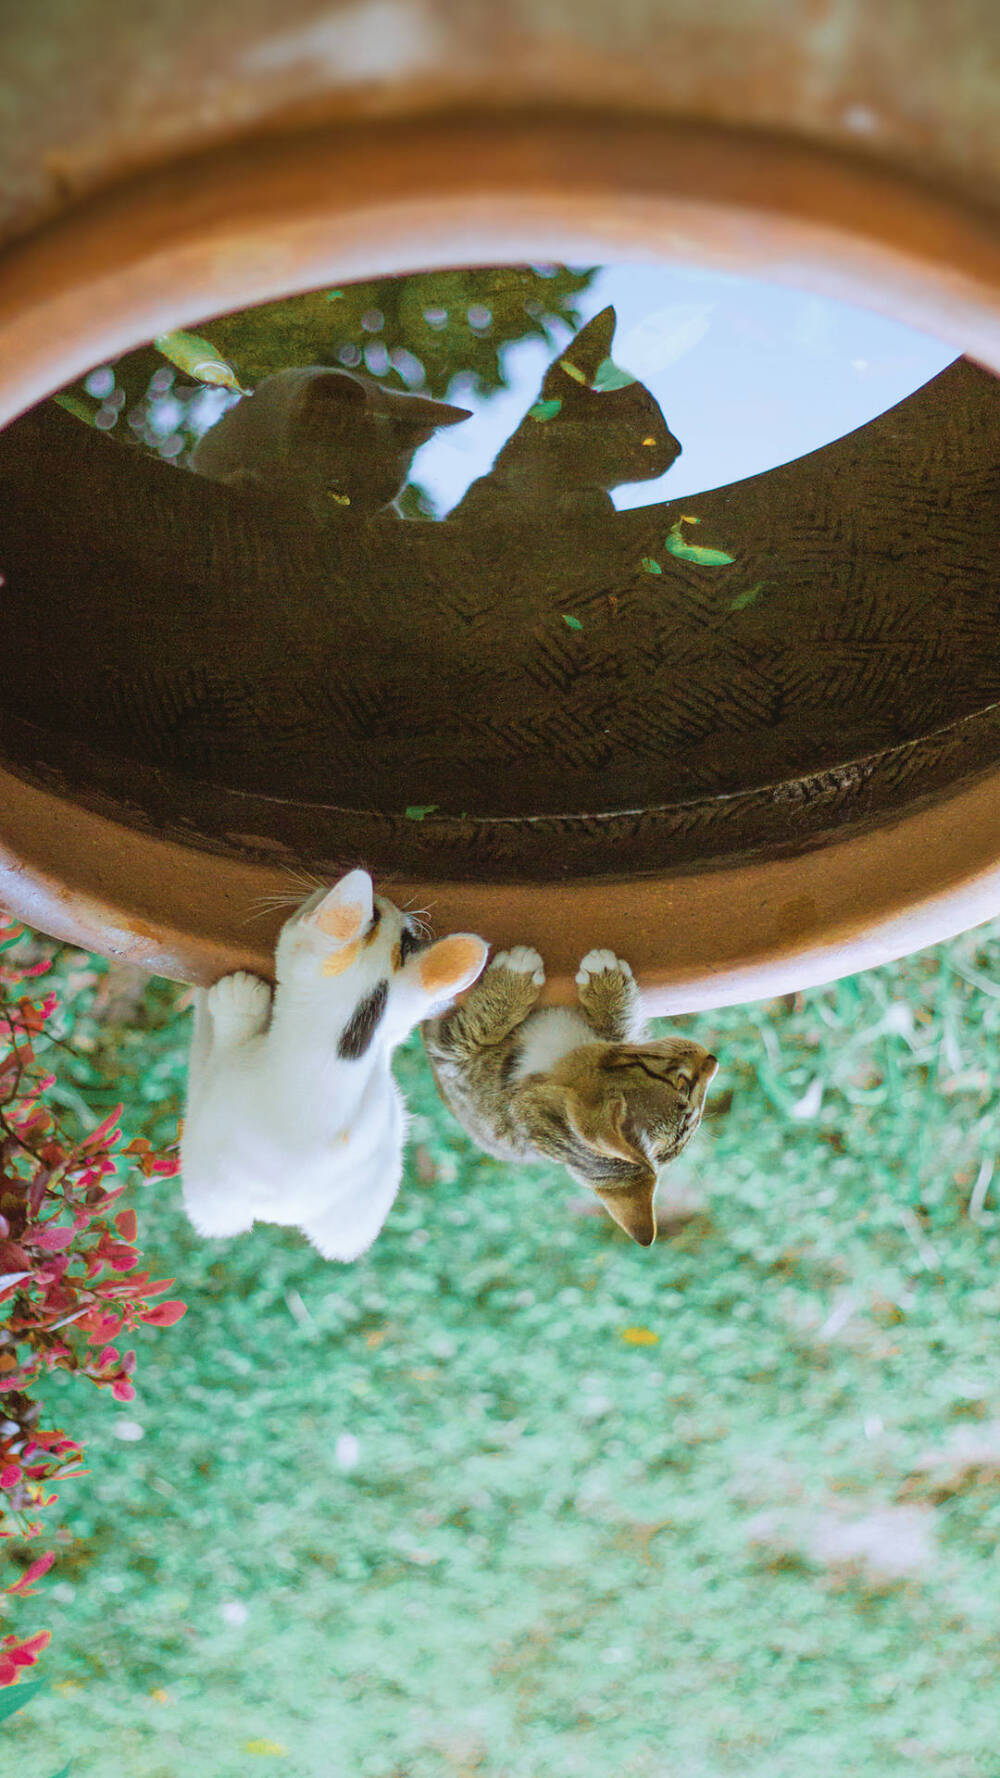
518 308 681 489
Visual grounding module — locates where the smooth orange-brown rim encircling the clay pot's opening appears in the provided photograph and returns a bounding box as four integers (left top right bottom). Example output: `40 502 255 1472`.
0 110 1000 1010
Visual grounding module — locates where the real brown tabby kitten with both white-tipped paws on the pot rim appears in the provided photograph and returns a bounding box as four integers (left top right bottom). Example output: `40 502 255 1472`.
423 946 717 1246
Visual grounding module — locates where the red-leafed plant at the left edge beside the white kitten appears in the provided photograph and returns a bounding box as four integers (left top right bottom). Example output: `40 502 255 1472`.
0 910 185 1686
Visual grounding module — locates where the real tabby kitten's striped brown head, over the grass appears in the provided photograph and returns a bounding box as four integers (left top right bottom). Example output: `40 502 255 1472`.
546 1037 719 1246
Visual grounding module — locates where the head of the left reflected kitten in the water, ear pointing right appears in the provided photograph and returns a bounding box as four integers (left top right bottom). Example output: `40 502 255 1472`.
290 366 470 514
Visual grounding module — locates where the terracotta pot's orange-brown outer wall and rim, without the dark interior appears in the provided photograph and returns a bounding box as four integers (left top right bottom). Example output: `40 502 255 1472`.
0 0 1000 1010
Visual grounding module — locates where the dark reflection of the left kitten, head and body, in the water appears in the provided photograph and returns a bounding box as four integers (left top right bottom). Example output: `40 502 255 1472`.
190 364 470 521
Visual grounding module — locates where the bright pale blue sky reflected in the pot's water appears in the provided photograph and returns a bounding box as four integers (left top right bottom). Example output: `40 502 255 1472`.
413 265 956 514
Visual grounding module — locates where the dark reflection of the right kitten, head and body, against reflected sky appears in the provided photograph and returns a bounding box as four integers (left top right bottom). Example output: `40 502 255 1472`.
448 308 681 519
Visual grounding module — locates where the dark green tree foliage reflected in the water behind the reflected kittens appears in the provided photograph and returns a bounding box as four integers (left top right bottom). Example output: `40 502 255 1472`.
54 265 593 459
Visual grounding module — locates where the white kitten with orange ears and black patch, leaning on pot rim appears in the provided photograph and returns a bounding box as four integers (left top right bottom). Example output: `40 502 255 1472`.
181 871 488 1261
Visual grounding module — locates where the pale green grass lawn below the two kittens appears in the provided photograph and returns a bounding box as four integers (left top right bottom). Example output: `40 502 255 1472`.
0 928 1000 1778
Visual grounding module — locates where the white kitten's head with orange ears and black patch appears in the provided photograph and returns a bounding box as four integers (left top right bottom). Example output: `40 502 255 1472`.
276 871 489 1061
